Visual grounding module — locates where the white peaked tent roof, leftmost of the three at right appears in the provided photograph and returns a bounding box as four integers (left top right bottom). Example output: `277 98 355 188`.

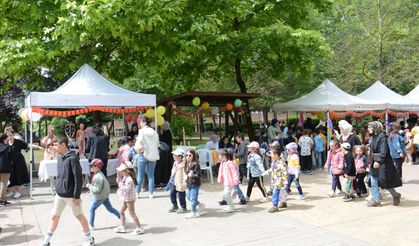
273 80 383 112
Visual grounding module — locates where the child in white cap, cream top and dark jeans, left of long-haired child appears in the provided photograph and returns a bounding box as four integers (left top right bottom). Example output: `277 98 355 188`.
169 149 187 214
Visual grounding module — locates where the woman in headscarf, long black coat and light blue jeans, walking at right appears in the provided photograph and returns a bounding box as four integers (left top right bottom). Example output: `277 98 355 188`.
368 121 402 207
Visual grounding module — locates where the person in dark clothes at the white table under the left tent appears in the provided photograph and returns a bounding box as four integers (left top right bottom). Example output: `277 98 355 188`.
86 122 109 177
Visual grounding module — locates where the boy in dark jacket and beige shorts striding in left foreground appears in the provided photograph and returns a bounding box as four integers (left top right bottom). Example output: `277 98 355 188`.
42 138 95 246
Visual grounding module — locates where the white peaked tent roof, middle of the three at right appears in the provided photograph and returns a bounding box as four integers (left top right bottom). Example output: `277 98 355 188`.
357 81 419 110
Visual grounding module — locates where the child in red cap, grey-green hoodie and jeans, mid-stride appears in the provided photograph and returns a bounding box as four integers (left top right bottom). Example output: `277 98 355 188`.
87 159 120 231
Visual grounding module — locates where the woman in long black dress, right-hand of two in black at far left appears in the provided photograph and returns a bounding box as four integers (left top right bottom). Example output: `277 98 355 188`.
6 128 30 199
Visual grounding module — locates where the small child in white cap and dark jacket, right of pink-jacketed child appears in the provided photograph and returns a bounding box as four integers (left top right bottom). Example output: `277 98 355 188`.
342 142 356 202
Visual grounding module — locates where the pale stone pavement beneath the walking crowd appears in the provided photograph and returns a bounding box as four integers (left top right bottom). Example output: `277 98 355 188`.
0 165 419 246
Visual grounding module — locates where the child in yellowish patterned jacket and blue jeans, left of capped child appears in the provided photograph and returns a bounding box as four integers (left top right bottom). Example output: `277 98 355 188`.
264 146 288 213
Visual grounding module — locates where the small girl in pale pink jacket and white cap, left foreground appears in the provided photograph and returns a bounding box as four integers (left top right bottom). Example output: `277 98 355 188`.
115 162 144 235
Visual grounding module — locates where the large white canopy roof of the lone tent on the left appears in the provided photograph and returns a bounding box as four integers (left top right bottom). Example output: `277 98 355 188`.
25 64 156 108
